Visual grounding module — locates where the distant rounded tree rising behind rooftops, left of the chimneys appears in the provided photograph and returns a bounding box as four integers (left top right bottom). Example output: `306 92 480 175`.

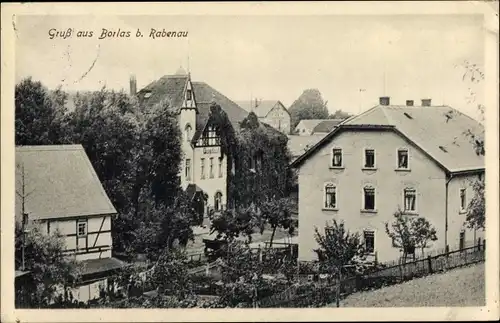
288 89 328 129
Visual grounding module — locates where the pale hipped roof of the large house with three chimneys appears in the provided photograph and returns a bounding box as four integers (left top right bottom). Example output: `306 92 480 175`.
292 105 484 173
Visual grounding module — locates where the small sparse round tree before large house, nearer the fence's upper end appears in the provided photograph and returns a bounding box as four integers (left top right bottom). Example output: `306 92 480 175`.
385 209 438 263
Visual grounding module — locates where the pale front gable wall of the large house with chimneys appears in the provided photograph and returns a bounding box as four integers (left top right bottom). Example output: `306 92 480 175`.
299 131 445 261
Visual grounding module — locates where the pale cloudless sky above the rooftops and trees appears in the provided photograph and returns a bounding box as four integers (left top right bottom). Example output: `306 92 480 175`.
16 15 484 117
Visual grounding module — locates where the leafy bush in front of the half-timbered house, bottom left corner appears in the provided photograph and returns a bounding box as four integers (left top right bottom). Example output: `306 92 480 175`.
15 223 82 307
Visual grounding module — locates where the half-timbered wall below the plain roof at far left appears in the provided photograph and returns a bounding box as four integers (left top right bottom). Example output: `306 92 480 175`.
46 215 113 260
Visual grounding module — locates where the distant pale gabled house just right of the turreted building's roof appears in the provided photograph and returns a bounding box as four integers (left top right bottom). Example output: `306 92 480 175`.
236 100 291 135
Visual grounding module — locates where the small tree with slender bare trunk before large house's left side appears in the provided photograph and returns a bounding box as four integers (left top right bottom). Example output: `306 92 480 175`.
315 220 365 307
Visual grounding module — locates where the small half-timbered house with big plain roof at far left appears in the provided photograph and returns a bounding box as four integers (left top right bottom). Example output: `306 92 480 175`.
15 145 125 302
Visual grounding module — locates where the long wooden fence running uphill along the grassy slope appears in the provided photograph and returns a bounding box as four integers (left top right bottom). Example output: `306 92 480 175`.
259 240 486 308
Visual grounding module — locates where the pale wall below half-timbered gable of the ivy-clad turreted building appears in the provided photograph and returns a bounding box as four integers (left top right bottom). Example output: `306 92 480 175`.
194 147 227 211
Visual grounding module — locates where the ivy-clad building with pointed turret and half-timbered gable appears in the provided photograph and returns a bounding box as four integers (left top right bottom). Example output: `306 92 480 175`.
131 69 248 214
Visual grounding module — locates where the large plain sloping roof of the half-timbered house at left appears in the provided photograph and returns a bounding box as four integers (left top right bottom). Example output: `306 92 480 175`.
16 145 116 219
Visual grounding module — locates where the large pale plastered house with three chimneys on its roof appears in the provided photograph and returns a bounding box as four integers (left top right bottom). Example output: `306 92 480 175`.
291 97 485 261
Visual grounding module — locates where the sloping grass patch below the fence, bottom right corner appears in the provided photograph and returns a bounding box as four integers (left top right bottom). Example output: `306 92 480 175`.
328 263 486 307
